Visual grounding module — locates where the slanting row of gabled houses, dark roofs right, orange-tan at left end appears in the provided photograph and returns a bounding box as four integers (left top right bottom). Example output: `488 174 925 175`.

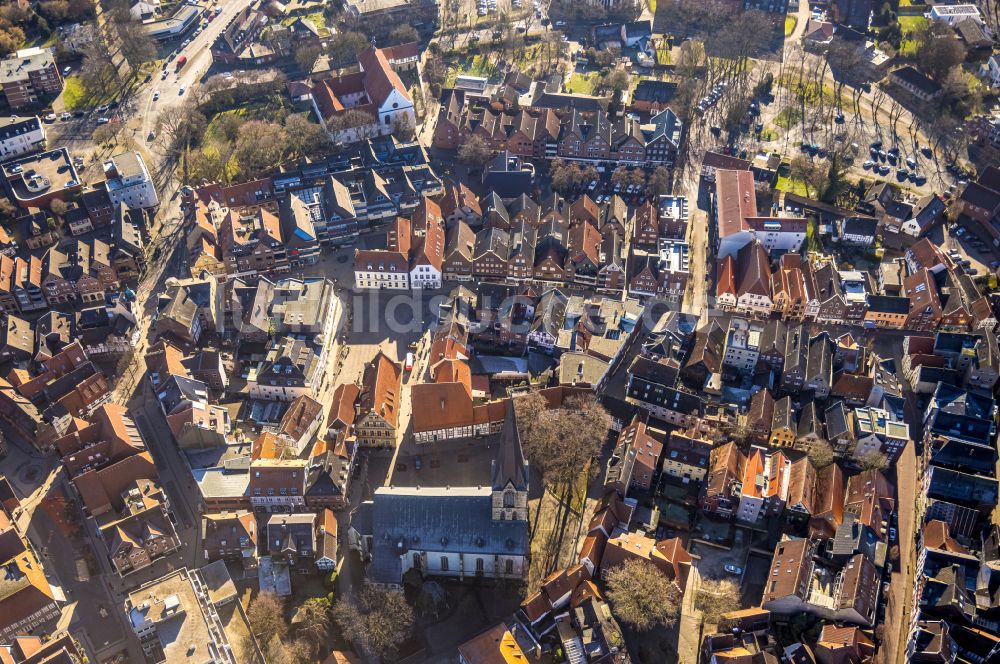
186 137 442 277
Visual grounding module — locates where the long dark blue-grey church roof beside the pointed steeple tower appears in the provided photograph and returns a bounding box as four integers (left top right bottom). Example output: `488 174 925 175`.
368 487 529 583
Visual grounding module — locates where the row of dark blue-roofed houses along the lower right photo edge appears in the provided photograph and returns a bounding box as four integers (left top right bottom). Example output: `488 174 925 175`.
906 376 1000 661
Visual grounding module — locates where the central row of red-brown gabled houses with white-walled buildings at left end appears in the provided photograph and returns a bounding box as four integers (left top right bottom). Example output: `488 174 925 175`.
355 185 690 302
